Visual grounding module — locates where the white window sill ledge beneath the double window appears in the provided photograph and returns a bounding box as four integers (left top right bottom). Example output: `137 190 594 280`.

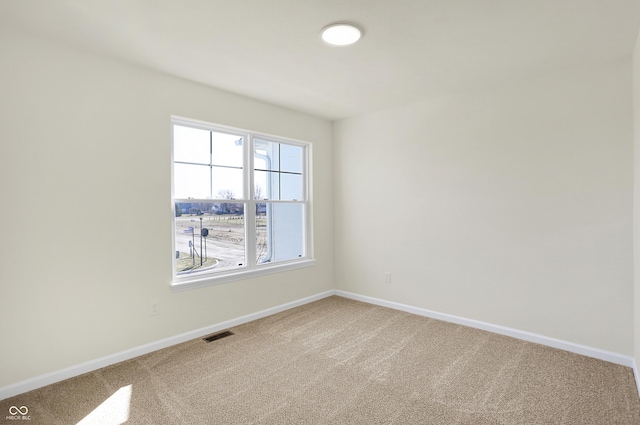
171 259 316 292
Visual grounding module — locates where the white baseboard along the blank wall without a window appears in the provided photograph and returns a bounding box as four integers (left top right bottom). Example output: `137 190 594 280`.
336 290 640 368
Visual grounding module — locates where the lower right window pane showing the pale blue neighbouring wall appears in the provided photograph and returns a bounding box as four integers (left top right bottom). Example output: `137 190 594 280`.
256 202 305 264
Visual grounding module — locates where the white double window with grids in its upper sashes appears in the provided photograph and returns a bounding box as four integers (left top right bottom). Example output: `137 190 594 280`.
172 118 313 288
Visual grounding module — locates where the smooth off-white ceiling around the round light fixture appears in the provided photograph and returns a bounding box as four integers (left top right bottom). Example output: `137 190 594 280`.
0 0 640 120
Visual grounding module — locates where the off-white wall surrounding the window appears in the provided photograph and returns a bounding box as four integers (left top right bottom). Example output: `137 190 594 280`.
0 29 333 387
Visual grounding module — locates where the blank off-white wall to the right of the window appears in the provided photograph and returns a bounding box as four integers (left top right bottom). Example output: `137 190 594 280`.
334 61 633 355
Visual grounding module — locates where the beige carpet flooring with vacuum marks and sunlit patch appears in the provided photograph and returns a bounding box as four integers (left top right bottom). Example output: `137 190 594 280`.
0 297 640 425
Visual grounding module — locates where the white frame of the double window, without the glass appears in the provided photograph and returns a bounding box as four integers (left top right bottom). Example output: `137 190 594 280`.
171 116 315 291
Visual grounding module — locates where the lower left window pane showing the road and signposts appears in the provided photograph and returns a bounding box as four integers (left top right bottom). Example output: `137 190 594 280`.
175 202 245 275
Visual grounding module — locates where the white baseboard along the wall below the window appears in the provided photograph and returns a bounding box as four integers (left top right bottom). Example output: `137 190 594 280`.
0 290 335 400
